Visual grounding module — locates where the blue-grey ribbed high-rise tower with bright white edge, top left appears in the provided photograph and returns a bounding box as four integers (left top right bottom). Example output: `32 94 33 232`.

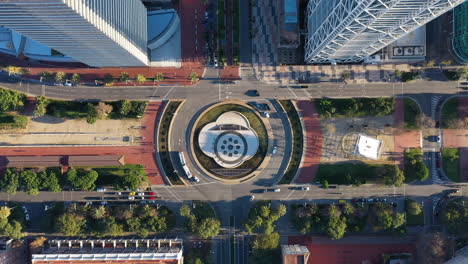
0 0 148 67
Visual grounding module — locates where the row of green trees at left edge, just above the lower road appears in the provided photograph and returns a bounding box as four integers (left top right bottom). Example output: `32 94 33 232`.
0 168 62 195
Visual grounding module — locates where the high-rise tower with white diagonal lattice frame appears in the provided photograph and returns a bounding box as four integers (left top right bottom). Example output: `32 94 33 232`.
305 0 465 63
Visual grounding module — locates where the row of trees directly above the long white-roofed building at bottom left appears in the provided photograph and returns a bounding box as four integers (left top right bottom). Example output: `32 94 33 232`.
51 204 174 237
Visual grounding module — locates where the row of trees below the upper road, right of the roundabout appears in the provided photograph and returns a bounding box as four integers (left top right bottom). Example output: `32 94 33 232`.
315 97 395 118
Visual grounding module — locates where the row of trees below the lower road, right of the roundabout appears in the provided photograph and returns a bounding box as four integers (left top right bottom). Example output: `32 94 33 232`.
293 203 405 239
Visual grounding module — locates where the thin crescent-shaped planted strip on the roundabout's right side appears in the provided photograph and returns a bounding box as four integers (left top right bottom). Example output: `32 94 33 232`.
279 100 304 184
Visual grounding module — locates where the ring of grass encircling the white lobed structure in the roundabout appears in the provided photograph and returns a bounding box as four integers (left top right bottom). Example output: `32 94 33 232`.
193 104 268 179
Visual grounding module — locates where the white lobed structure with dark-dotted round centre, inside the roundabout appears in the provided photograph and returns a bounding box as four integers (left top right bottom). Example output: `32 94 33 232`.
198 112 259 168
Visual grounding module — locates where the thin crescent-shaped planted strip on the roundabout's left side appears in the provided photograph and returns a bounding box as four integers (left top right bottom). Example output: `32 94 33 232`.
158 101 183 185
